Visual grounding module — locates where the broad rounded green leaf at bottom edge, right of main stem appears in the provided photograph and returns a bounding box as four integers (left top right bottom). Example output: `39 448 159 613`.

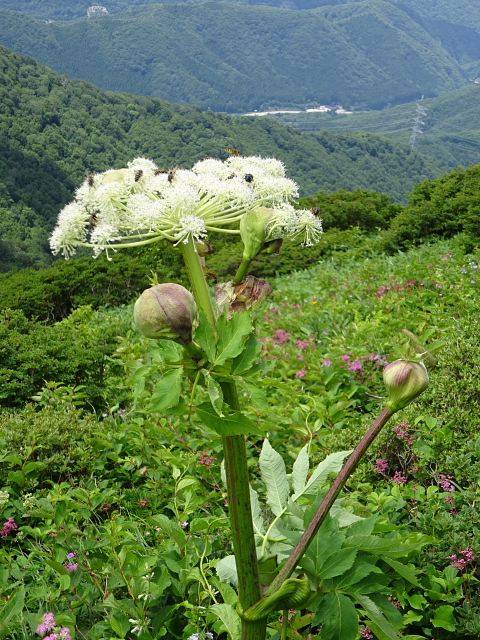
313 591 358 640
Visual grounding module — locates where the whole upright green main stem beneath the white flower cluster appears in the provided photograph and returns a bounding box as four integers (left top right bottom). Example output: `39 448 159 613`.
180 240 267 640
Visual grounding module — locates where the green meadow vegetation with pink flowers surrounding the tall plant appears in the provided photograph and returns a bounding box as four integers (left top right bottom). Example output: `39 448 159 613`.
0 224 480 640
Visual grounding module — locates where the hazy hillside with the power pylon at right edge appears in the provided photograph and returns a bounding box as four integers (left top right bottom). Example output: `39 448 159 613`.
269 84 480 168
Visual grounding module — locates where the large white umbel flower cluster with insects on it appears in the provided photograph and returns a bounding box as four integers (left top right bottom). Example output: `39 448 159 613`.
50 156 321 258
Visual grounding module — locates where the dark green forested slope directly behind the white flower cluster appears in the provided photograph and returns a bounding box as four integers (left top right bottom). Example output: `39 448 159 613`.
0 46 443 271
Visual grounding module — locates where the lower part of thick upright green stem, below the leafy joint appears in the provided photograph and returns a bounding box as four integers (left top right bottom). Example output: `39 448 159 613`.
221 382 267 640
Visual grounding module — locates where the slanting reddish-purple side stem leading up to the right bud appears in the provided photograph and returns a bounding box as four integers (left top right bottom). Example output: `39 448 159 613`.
265 408 395 595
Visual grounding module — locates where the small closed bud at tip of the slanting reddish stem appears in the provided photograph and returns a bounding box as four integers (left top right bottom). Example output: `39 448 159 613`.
383 360 429 412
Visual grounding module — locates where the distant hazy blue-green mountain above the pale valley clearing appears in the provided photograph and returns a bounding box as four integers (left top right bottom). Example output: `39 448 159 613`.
0 0 468 112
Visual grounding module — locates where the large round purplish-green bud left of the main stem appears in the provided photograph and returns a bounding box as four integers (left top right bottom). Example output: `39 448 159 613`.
133 283 197 344
